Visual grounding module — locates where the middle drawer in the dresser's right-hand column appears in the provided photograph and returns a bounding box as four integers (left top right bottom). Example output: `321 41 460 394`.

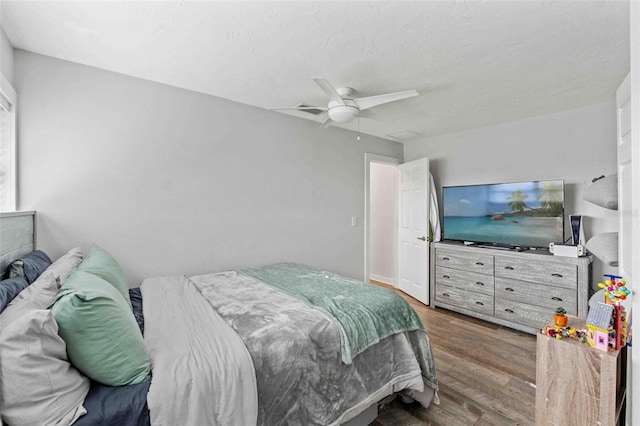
495 277 578 315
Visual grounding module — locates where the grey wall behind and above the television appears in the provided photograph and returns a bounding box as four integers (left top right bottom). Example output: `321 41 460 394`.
404 102 618 283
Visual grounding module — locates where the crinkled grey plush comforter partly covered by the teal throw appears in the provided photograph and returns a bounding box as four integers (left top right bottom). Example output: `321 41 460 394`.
189 271 437 425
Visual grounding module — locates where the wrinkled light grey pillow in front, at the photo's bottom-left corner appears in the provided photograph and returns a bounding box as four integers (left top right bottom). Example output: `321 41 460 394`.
0 310 89 426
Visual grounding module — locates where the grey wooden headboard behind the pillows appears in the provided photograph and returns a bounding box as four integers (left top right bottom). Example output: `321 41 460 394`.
0 211 36 273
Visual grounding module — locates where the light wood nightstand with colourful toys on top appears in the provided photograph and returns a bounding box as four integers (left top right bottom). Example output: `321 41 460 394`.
536 316 627 426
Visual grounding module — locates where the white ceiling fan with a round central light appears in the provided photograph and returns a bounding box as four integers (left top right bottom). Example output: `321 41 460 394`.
272 78 419 127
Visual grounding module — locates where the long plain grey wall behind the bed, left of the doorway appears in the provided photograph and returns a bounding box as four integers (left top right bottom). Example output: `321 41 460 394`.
14 50 402 285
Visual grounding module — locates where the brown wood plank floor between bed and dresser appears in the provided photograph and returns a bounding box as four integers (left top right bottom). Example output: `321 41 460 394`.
372 281 536 426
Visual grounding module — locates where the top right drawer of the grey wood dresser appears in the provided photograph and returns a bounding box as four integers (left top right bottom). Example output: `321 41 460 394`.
495 256 578 288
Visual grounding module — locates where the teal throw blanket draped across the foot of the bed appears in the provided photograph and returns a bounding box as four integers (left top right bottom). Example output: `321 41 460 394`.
241 263 423 364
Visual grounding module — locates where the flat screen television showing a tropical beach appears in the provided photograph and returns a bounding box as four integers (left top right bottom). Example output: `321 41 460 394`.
442 180 564 248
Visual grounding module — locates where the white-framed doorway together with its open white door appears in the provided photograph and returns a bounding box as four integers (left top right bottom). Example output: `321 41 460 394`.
364 154 431 305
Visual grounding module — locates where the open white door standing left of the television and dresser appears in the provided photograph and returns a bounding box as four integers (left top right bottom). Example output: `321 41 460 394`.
398 158 429 304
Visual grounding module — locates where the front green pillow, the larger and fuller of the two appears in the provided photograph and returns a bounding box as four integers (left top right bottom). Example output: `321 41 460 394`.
51 270 150 386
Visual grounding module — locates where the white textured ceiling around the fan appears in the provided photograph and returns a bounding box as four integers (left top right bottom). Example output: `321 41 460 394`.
0 0 630 142
